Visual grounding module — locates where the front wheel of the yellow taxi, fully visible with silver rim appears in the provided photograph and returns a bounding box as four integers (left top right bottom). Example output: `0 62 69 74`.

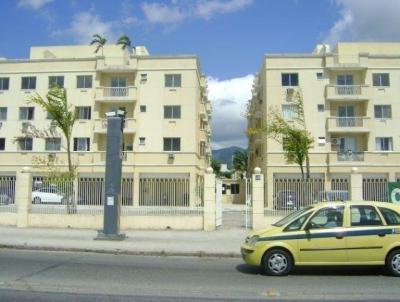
263 249 293 276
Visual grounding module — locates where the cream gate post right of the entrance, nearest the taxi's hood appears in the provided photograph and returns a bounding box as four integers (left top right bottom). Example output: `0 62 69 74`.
251 167 266 230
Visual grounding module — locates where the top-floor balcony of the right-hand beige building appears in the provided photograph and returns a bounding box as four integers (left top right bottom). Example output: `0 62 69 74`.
325 85 371 101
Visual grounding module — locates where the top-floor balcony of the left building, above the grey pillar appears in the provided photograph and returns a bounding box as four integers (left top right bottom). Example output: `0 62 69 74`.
95 86 137 103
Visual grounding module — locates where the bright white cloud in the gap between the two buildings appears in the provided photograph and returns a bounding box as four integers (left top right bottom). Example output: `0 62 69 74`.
207 75 254 149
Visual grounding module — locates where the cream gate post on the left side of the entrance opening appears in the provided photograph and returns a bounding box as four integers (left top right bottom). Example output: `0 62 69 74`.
203 167 216 231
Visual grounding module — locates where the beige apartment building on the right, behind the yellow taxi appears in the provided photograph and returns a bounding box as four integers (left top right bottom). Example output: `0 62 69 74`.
248 43 400 207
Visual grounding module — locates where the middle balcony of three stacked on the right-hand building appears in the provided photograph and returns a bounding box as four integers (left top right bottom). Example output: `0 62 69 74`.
327 117 371 133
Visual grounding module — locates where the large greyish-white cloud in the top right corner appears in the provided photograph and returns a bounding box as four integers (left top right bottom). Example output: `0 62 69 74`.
325 0 400 45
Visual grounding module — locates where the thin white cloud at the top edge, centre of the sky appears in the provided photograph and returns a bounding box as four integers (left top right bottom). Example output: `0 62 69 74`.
141 0 253 25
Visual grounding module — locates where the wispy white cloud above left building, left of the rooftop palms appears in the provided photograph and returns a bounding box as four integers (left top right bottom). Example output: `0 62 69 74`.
53 10 117 44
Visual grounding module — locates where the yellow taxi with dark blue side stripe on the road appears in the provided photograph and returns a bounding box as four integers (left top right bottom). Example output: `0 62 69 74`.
241 201 400 276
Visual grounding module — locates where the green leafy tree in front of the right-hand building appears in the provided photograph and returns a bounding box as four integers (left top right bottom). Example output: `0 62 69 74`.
265 92 314 179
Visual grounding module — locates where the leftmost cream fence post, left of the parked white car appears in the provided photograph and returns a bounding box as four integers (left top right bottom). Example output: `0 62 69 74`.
15 167 32 228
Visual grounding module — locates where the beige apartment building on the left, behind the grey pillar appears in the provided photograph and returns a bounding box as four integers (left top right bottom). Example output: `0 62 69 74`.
0 45 211 206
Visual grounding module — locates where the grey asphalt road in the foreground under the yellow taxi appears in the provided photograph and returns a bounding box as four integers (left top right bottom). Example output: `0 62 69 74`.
0 249 400 302
